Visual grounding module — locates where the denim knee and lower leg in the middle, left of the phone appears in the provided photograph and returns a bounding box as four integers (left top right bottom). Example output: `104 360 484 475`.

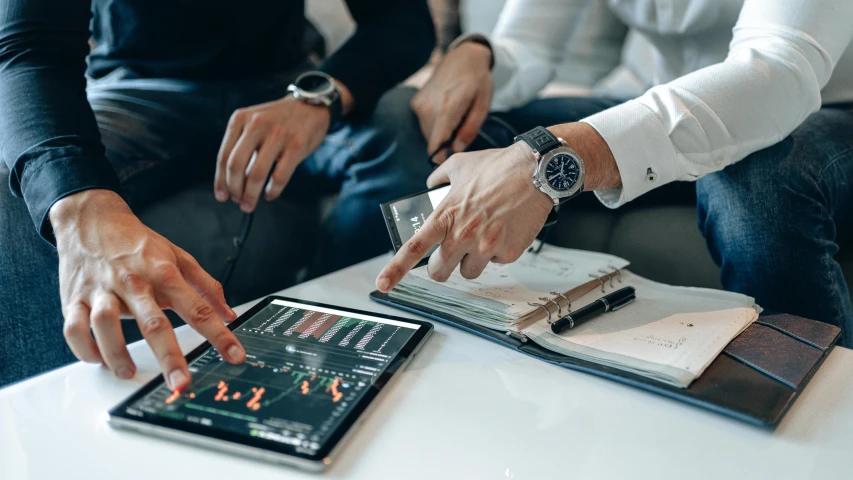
298 87 432 277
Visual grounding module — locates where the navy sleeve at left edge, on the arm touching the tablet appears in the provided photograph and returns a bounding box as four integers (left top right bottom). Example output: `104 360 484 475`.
0 0 120 242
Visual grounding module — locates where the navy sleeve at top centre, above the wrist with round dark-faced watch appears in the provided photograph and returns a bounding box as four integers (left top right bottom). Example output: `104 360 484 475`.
320 0 435 112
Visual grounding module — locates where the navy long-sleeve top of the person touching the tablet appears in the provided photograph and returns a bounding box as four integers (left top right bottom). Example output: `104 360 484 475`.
0 0 435 241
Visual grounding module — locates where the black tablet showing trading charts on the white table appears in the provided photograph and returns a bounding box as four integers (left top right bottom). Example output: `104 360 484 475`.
109 297 432 470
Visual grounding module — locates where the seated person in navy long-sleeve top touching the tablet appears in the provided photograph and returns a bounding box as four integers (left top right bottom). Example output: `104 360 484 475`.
0 0 435 388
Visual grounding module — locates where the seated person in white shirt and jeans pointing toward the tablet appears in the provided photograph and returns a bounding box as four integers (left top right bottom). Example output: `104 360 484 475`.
376 0 853 346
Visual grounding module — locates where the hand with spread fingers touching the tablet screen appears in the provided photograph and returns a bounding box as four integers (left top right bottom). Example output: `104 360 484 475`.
50 190 246 390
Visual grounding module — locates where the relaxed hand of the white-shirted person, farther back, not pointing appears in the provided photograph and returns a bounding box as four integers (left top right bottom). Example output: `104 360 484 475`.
411 42 492 164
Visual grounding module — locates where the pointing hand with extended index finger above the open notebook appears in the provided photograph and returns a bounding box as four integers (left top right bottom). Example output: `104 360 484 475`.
376 142 554 292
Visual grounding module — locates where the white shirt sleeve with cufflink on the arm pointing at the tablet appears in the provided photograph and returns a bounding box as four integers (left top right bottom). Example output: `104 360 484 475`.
583 0 853 207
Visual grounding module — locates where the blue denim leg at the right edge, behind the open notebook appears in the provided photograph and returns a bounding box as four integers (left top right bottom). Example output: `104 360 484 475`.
697 107 853 347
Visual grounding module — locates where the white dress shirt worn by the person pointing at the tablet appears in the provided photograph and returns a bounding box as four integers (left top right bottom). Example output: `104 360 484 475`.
470 0 853 208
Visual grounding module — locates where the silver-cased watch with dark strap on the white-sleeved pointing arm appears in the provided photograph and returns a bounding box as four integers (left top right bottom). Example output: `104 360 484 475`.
515 127 584 206
